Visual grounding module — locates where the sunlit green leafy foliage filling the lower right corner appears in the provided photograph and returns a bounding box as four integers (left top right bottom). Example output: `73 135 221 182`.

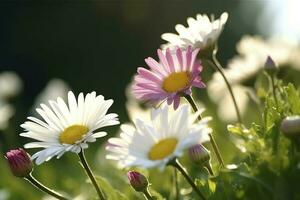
226 81 300 199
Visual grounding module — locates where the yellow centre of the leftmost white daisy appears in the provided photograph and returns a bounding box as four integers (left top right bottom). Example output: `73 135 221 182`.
59 125 89 144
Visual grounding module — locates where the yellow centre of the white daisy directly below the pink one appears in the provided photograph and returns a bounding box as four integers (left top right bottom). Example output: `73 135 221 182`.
148 138 178 160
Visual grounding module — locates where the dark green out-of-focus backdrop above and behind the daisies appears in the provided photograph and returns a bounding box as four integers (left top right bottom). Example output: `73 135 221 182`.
0 0 259 122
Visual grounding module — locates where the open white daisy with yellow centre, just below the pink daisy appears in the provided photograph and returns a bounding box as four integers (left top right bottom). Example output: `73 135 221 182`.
106 105 211 169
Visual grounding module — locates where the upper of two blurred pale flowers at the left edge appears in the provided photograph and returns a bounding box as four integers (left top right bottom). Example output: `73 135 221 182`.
0 71 22 99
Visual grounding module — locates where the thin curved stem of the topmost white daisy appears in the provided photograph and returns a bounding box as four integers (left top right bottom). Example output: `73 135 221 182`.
208 50 242 123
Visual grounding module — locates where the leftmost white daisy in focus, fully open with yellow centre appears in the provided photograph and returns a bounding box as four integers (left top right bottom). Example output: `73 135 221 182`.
20 92 119 164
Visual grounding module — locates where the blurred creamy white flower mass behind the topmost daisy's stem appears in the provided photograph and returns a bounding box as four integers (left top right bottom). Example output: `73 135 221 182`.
207 36 300 121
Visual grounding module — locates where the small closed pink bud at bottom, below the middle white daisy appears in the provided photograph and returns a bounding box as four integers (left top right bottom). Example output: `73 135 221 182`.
127 171 149 192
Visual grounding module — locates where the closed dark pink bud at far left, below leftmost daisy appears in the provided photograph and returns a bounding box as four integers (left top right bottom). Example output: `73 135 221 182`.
4 148 33 178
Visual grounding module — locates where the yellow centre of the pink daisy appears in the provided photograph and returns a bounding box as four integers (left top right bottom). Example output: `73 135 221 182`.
162 72 189 92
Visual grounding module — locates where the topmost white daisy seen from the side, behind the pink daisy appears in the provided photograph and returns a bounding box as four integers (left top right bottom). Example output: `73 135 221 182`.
161 12 228 49
